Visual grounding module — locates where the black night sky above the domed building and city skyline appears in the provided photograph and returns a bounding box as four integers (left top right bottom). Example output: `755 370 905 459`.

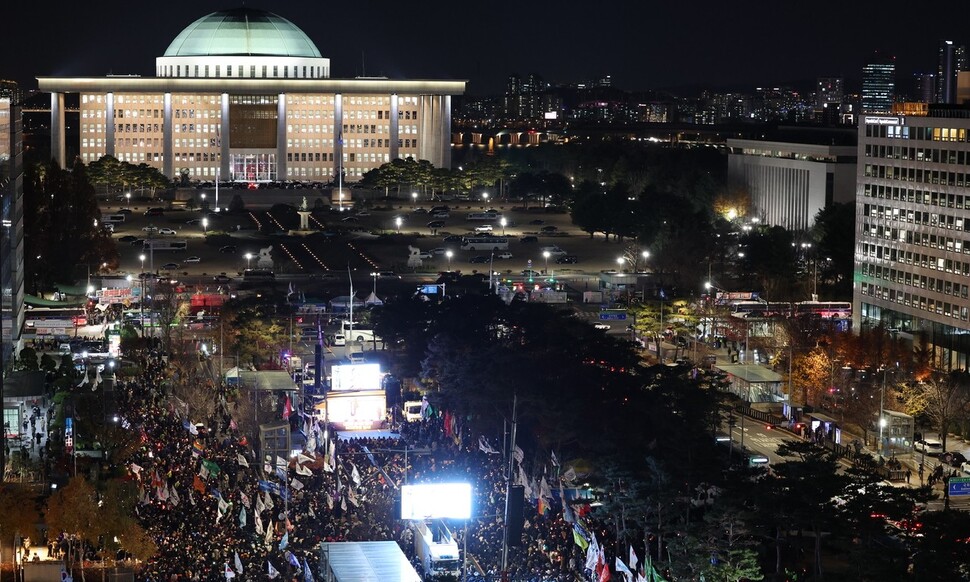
7 0 970 95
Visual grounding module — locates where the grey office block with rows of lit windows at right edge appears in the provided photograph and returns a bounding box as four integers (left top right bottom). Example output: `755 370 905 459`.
853 106 970 369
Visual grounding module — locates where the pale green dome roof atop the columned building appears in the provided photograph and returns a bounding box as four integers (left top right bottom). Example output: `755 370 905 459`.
165 7 320 58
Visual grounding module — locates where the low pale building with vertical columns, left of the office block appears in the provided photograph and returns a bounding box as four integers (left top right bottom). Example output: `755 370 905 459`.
727 129 857 230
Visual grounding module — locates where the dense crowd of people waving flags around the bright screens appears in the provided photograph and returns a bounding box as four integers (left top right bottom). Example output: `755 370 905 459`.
92 352 609 582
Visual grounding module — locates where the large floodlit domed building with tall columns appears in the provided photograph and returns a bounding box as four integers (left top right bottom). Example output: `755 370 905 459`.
37 7 465 182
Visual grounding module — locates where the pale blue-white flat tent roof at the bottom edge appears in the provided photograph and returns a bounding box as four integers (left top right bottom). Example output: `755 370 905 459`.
320 541 421 582
